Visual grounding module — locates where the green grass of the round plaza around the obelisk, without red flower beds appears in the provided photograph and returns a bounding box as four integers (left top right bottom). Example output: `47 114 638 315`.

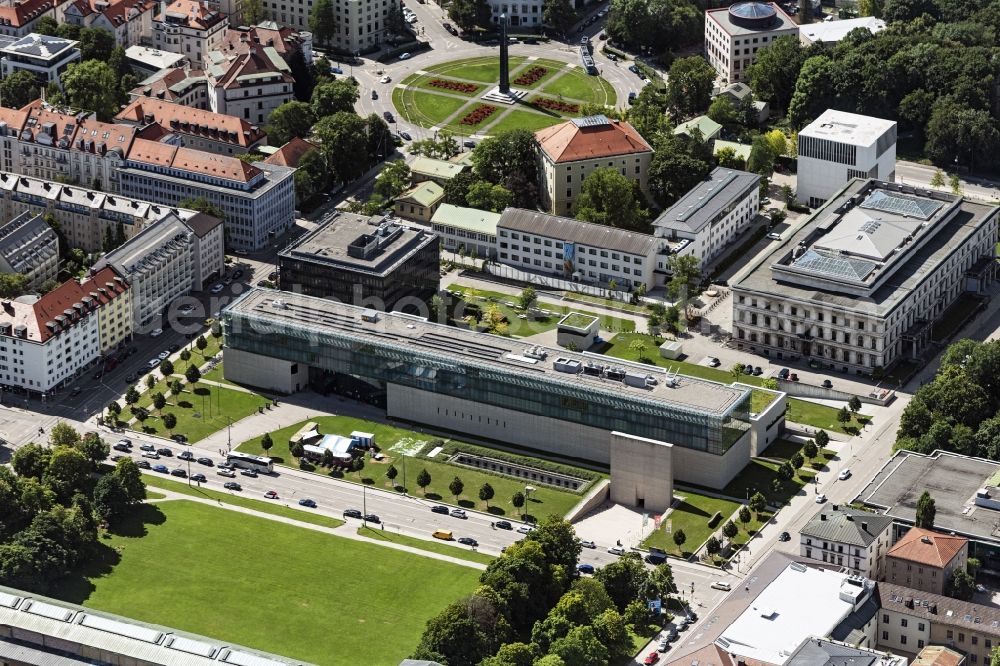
392 56 617 135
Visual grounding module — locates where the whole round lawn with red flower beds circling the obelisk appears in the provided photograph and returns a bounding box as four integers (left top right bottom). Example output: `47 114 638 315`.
392 56 617 136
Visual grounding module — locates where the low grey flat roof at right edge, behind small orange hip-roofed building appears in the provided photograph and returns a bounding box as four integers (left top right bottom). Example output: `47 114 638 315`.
857 450 1000 541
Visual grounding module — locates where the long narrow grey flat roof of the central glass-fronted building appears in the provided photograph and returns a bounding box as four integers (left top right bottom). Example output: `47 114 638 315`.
223 288 749 417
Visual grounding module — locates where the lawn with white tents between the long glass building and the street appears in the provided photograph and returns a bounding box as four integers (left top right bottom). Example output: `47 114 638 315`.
237 416 582 519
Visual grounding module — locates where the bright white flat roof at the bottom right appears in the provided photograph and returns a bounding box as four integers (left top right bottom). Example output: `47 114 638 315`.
715 563 874 665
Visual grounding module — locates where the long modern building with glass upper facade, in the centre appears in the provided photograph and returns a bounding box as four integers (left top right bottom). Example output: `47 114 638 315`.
222 290 750 486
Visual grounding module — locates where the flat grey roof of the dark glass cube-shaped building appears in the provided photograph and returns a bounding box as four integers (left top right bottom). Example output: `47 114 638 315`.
279 212 438 275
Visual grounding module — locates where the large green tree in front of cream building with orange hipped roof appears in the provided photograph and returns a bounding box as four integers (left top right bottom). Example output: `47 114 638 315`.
575 168 650 233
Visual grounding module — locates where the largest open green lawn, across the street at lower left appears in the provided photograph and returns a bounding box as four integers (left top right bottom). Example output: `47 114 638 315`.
55 501 479 666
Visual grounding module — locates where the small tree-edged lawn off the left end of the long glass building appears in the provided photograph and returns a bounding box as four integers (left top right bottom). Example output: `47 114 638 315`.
129 382 271 442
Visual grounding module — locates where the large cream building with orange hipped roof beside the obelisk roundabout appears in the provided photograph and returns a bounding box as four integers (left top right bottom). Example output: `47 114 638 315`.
535 115 653 215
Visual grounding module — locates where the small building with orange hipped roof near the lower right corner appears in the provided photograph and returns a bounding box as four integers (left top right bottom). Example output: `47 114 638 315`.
885 527 969 594
